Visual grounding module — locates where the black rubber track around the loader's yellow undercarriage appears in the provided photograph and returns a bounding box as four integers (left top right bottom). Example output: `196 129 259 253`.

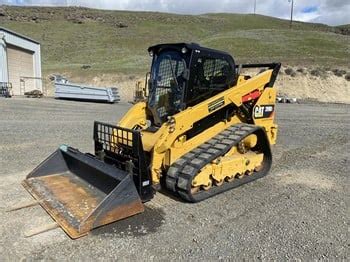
165 124 272 202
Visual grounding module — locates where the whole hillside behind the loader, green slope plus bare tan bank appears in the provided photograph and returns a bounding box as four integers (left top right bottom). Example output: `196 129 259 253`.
0 6 350 103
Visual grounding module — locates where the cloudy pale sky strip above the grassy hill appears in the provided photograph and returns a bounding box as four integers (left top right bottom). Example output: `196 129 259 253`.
0 0 350 25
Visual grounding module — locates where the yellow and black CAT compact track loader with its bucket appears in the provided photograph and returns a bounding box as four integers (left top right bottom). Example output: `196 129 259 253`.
23 43 280 238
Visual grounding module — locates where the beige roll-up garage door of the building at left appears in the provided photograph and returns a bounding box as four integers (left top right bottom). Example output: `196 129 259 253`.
7 46 35 95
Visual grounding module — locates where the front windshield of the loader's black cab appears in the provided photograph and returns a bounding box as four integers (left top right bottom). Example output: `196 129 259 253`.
148 51 186 125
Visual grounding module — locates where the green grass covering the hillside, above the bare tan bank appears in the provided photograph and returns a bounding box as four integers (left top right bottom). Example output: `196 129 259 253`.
0 7 350 75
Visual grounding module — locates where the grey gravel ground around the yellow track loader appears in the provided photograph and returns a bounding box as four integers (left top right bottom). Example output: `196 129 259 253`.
0 98 350 261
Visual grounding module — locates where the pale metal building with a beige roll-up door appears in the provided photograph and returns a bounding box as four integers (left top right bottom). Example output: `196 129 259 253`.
0 27 43 95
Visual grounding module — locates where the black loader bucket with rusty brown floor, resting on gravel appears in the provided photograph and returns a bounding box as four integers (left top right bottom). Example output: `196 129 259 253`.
22 145 144 238
